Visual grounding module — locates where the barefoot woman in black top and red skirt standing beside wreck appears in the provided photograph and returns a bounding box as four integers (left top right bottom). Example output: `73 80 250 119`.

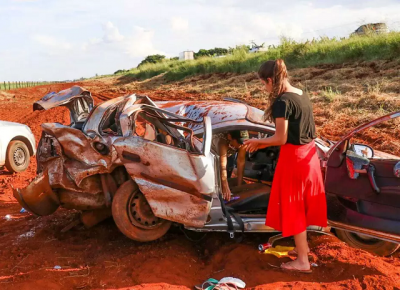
244 59 327 273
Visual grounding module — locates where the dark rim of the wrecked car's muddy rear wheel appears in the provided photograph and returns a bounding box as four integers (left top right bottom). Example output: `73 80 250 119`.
127 190 163 229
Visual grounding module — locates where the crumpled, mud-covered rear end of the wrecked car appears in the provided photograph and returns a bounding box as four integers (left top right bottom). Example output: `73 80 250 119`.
14 123 118 215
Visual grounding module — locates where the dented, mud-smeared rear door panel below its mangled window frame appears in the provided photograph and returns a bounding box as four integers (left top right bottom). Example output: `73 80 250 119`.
114 137 215 226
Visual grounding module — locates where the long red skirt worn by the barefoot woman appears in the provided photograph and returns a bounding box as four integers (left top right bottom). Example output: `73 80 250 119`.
265 141 327 237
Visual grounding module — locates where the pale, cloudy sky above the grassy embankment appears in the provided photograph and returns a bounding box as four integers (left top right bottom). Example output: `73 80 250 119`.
0 0 400 82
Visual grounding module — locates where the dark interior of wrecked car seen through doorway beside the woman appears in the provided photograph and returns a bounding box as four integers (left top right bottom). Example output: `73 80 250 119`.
220 131 279 214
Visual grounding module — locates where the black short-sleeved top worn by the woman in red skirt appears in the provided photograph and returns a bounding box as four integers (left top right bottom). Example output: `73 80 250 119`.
272 92 316 145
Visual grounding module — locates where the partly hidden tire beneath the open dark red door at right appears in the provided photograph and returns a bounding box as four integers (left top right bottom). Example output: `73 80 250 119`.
335 229 400 256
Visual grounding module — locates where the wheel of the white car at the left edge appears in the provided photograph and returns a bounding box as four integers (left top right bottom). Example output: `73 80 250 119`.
6 140 31 173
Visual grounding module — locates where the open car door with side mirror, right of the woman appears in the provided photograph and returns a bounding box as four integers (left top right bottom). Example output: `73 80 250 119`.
325 112 400 242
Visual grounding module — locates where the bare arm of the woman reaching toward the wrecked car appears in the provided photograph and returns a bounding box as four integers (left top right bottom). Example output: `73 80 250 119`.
244 118 288 152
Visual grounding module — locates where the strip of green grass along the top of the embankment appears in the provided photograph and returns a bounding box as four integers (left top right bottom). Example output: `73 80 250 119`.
120 32 400 81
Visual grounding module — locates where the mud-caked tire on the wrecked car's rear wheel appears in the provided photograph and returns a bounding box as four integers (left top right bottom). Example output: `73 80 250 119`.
112 180 171 242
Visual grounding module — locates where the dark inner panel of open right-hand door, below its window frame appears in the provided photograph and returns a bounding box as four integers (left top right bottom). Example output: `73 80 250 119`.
325 140 400 221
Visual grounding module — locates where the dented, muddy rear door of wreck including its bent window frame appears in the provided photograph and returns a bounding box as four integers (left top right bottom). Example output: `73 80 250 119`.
113 105 215 227
